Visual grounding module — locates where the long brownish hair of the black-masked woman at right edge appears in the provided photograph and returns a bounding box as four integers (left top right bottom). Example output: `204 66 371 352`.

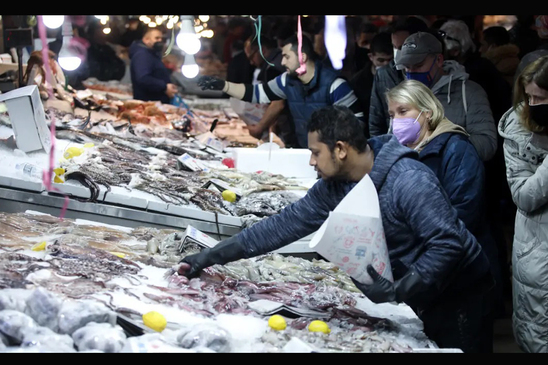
514 56 548 133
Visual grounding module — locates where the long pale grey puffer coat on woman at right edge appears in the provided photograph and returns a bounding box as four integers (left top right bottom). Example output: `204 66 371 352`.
499 109 548 352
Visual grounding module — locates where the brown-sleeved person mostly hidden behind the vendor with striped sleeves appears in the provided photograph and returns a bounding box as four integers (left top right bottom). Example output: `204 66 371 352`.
242 35 297 147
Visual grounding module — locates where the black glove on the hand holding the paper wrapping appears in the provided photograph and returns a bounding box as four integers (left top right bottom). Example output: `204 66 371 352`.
352 265 425 303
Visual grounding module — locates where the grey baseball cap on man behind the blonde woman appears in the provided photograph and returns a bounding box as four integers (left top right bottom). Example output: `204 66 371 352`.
395 32 443 66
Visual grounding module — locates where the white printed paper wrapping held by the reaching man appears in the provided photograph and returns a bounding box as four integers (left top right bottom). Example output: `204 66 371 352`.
310 175 394 284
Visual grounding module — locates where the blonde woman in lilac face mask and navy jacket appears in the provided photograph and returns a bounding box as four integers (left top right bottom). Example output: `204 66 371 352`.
386 80 502 352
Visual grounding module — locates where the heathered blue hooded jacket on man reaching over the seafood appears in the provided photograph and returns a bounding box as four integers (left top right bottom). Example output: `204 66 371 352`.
238 135 489 308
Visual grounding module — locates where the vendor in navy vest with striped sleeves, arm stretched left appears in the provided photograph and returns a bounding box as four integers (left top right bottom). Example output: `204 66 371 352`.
198 35 365 148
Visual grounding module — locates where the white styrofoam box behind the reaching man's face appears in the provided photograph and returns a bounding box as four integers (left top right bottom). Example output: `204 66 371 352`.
232 148 318 179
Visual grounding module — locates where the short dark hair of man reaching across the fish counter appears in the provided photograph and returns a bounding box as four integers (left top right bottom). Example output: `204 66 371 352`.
307 105 367 153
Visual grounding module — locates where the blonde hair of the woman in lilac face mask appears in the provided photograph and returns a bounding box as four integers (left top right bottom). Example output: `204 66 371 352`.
386 80 445 131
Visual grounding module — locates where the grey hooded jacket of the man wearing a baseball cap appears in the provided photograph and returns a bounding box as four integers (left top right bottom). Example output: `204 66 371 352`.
432 61 497 161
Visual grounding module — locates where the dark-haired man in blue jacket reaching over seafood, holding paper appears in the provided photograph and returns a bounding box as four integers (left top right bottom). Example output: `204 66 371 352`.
177 105 493 352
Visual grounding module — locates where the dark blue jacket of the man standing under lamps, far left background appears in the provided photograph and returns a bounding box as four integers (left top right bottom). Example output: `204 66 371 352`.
129 40 171 104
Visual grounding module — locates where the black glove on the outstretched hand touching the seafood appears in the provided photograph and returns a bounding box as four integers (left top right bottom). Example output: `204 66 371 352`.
179 236 246 279
